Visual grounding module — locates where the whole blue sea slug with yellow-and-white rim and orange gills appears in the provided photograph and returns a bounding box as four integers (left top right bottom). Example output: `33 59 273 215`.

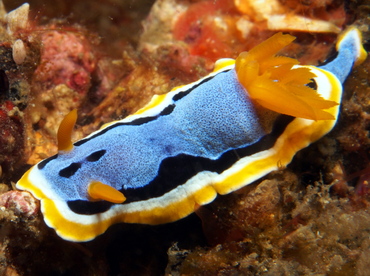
16 28 366 241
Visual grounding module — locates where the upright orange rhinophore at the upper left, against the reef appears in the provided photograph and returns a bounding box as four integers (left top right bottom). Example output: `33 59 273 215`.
57 109 77 152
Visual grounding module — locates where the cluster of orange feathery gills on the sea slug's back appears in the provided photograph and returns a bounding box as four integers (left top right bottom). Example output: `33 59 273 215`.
235 33 338 120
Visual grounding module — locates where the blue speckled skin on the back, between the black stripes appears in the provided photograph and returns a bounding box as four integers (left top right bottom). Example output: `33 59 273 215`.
41 70 264 201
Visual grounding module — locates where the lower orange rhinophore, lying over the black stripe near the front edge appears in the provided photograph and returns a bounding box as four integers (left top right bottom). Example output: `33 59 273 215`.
87 181 126 203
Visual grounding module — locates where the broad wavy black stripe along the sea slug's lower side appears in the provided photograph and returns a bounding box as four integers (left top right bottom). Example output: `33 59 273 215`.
67 115 294 215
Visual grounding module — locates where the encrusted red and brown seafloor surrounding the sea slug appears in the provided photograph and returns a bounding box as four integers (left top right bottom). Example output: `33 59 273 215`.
0 0 370 275
